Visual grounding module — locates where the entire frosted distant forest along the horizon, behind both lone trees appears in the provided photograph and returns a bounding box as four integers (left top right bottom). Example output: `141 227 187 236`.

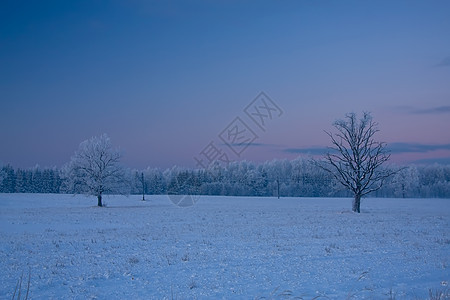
0 158 450 198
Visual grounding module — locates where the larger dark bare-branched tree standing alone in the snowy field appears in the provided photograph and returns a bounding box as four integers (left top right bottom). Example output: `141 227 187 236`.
319 112 395 213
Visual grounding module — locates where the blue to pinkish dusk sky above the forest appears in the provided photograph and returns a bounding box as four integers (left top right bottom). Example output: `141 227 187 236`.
0 0 450 169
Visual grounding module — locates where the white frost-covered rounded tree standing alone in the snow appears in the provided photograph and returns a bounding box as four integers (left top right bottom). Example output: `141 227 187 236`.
64 134 126 206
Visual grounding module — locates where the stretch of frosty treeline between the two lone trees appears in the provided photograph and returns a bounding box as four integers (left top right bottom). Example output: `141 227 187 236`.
133 159 338 197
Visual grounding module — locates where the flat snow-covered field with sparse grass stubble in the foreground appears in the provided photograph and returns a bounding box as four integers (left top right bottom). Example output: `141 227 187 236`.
0 194 450 299
